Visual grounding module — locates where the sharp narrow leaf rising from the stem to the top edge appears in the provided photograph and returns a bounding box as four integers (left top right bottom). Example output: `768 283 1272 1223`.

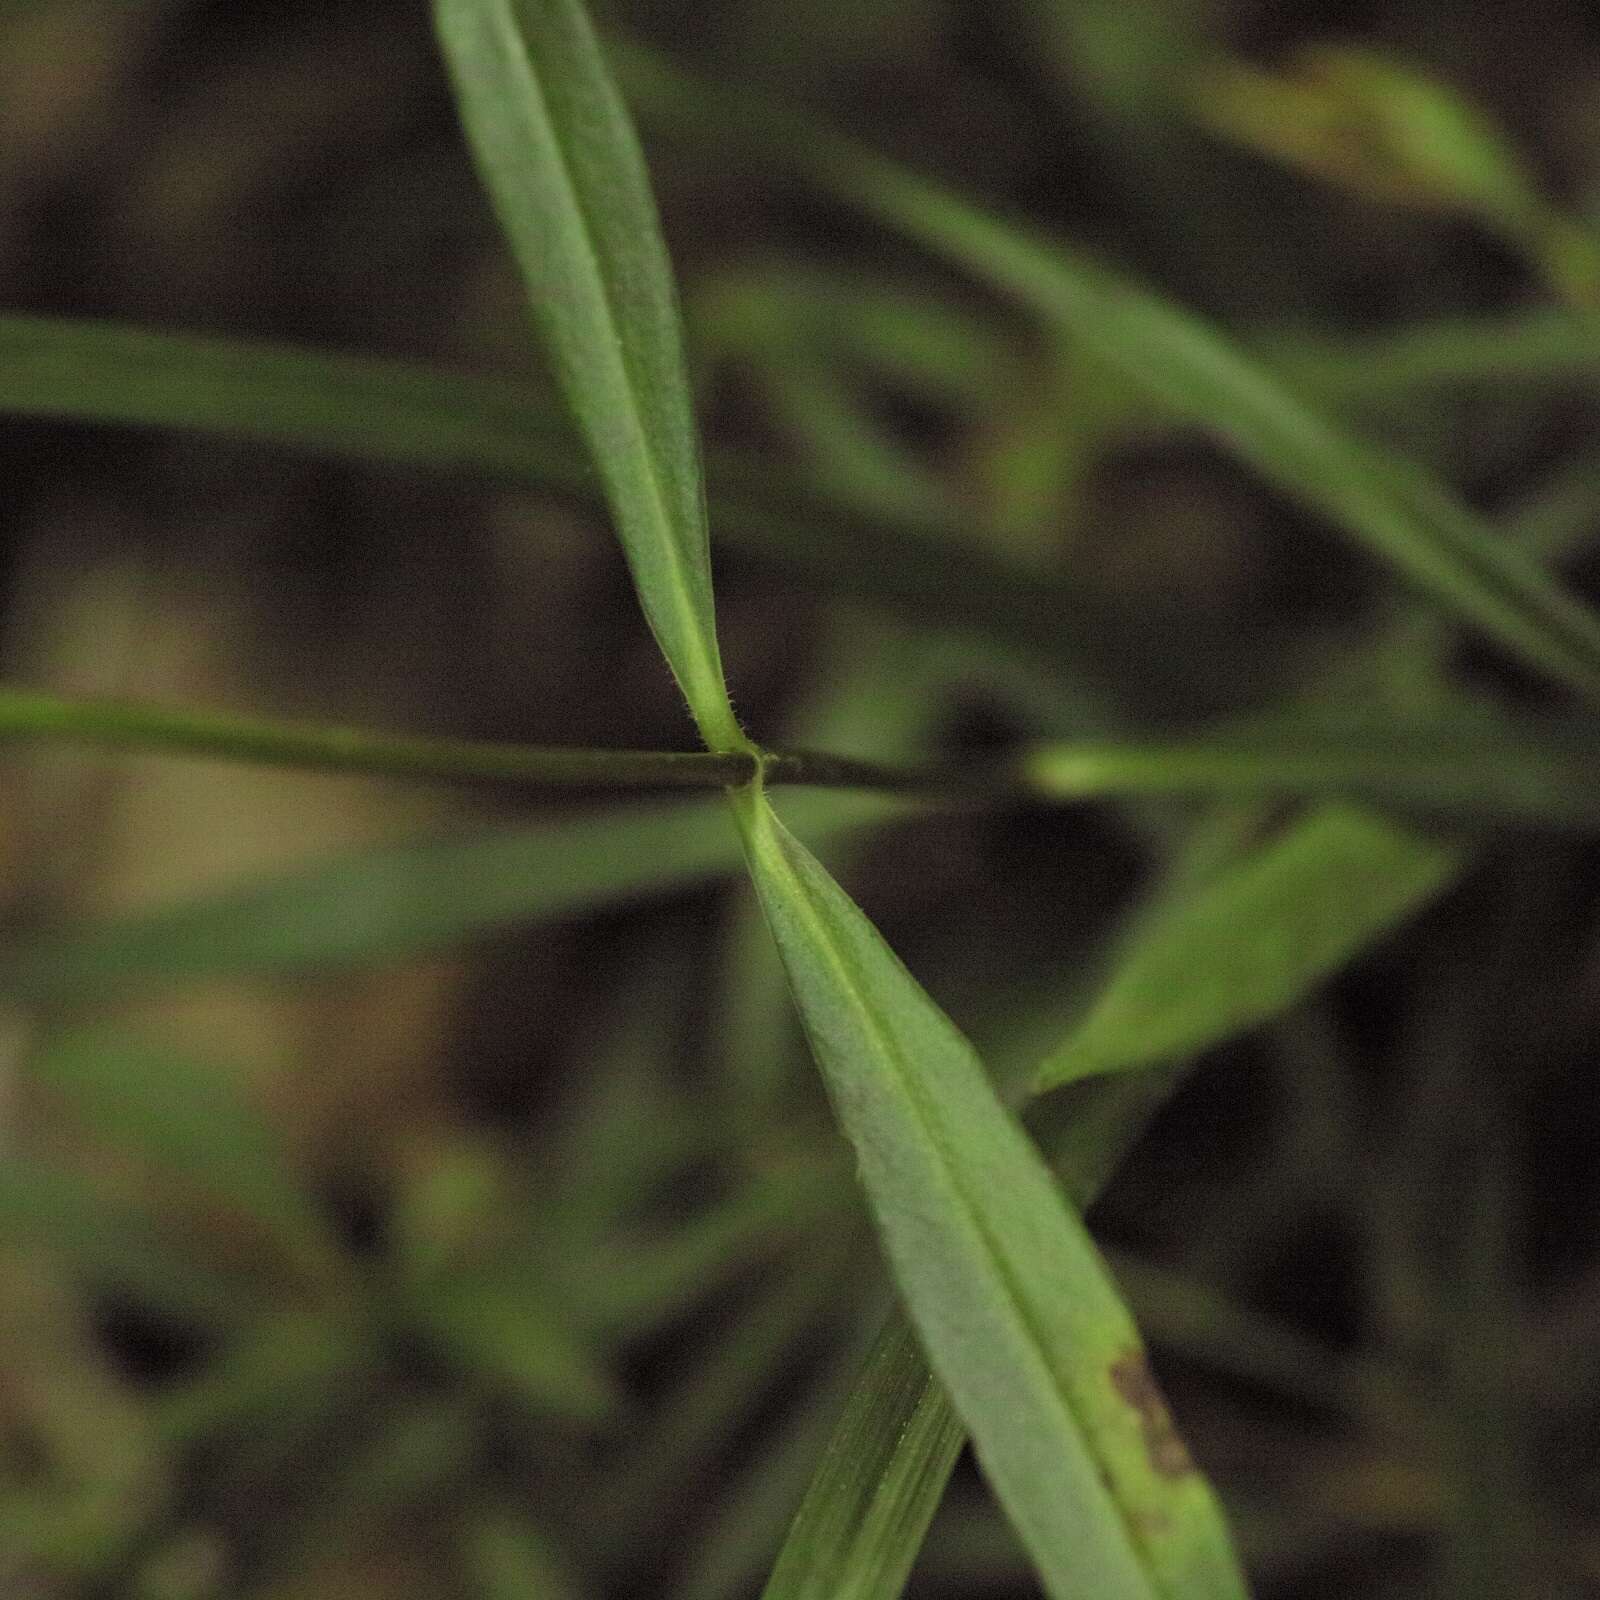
435 0 750 750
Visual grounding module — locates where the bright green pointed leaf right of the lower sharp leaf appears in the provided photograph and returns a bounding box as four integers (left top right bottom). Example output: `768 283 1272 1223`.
1035 805 1464 1090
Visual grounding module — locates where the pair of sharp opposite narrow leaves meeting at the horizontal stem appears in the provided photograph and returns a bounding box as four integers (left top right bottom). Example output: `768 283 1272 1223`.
437 0 1243 1600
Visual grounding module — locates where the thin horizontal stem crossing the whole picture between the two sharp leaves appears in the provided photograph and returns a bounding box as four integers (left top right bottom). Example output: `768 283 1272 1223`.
9 688 1600 829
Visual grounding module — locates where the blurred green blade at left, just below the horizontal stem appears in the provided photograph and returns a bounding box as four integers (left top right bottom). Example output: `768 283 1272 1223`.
0 792 902 1003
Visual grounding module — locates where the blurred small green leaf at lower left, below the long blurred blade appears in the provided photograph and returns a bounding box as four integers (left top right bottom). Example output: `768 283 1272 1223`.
29 1027 341 1275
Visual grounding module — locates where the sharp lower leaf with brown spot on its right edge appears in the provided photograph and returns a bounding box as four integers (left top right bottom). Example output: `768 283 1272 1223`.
733 789 1243 1600
